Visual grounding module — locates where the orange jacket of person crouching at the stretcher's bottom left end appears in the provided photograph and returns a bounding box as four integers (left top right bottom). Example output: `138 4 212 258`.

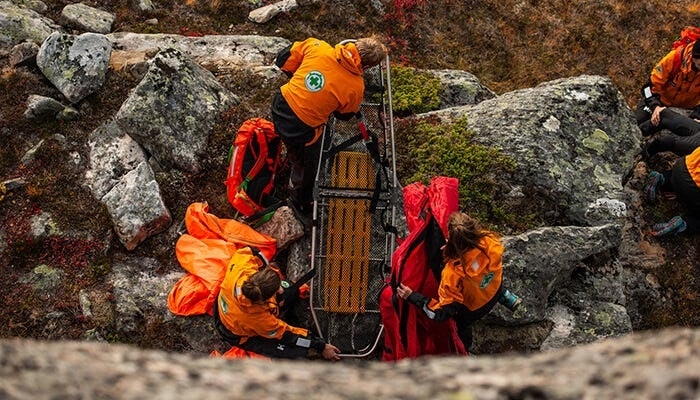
218 247 308 344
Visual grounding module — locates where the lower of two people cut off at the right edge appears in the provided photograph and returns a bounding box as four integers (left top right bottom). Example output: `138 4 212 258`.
643 147 700 236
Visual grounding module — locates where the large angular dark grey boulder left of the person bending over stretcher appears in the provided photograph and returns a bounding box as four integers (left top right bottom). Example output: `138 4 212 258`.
115 49 238 173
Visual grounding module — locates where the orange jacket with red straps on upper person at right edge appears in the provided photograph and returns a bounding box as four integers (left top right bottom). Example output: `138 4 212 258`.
650 42 700 108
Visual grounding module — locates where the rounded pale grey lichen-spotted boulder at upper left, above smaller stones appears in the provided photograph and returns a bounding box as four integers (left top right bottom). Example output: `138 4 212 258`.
36 32 112 103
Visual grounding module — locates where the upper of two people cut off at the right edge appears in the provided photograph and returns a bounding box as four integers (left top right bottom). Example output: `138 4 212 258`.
635 41 700 136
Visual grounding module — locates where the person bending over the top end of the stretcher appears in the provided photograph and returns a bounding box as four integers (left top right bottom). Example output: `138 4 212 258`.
271 37 387 214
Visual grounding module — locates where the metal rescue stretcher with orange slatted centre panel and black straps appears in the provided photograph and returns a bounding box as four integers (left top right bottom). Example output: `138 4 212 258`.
309 52 398 357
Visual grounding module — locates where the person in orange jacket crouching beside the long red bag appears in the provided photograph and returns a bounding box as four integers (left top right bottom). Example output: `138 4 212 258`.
397 212 521 349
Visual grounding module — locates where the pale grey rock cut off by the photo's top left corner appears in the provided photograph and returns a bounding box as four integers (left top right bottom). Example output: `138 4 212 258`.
0 1 60 50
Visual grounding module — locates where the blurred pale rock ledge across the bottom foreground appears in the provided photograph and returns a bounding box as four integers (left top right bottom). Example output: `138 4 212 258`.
0 329 700 400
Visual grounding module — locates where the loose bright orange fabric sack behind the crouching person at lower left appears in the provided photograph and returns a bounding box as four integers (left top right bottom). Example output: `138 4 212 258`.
168 203 277 316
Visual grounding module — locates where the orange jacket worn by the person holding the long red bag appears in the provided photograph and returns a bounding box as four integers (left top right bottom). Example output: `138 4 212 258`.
428 235 503 311
